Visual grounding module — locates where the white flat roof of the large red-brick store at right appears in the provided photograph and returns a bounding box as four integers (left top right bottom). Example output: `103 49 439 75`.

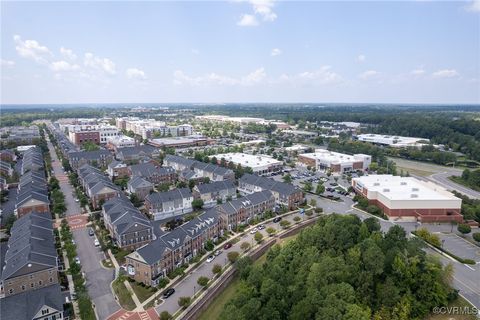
352 174 460 200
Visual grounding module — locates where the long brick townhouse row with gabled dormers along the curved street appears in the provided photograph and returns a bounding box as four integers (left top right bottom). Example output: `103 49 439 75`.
126 191 275 286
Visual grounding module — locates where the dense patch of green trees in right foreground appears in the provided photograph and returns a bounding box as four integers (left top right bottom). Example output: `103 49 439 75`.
220 215 456 320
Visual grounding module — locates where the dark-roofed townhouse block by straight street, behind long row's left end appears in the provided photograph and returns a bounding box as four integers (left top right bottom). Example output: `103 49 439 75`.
102 195 154 250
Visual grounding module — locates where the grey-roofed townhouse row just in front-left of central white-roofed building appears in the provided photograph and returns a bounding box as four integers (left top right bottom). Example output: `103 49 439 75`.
163 155 235 182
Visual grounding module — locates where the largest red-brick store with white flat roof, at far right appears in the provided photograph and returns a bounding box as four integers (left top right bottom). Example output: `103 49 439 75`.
352 175 463 222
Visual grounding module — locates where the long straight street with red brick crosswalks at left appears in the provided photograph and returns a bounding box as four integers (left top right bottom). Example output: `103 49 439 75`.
48 136 120 320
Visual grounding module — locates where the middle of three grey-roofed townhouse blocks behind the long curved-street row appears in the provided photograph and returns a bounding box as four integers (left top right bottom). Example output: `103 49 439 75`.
192 180 237 208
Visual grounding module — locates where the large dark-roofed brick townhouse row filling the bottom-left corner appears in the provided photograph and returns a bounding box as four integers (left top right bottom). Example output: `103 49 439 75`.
0 212 64 320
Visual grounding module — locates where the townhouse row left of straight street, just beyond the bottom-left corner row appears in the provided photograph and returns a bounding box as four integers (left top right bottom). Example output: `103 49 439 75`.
15 147 50 218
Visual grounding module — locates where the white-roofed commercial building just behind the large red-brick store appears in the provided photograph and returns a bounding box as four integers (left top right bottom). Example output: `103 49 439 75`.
298 149 372 173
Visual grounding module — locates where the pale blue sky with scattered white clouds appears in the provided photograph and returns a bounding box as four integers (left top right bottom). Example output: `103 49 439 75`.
0 0 480 104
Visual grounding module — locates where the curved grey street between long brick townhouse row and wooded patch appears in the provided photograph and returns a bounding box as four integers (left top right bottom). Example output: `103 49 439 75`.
155 210 304 314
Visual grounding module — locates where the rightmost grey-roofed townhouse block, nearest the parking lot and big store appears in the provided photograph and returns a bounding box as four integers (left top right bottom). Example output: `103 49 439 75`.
238 173 305 210
